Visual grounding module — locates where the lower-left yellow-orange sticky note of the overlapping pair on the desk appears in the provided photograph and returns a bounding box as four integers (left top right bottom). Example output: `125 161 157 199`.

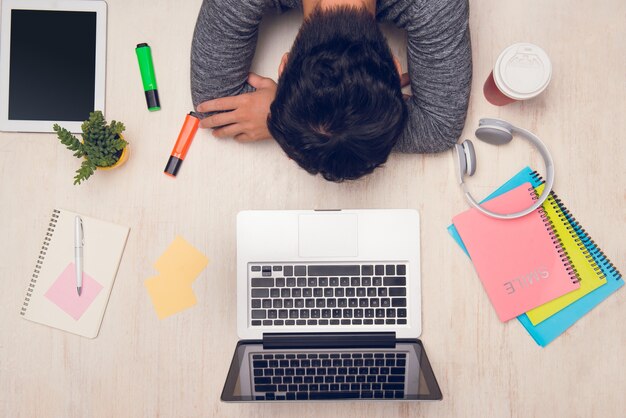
143 275 196 319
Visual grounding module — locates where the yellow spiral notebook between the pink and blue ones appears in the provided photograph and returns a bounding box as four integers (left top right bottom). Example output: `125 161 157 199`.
526 184 606 325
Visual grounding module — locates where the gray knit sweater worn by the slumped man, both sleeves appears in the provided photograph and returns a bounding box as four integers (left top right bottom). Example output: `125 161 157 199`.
191 0 472 153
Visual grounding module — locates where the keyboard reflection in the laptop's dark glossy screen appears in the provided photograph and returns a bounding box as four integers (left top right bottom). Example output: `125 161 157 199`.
251 351 407 400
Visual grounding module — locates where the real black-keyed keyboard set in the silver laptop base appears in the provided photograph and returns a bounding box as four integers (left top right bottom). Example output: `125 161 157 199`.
248 264 407 326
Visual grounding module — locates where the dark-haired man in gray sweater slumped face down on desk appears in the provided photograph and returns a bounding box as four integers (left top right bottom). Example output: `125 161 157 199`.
191 0 472 181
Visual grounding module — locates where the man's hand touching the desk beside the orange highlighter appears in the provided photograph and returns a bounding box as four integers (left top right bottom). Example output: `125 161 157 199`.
196 73 276 142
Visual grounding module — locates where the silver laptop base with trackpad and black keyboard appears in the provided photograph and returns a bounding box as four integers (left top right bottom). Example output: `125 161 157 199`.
237 209 421 339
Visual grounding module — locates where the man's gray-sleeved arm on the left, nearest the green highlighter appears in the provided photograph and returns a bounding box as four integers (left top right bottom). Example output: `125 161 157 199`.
191 0 266 108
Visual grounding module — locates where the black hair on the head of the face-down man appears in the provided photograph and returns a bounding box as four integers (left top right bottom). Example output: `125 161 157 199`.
267 7 407 182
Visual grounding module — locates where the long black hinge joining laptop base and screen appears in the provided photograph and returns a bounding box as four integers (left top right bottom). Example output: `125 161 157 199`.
263 332 396 349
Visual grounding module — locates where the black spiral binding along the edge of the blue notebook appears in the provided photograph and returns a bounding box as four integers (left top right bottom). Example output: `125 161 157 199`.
532 171 622 280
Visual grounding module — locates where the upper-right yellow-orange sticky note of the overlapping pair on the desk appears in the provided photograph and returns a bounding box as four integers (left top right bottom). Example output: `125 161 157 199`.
154 236 209 283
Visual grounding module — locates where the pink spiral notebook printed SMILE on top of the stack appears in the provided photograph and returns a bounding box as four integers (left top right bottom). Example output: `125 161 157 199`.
452 183 580 322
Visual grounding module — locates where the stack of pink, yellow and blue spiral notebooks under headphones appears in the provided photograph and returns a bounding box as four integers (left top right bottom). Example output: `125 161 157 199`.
448 167 624 346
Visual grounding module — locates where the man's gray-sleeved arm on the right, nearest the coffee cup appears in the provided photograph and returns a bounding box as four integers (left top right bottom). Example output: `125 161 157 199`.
394 0 472 153
